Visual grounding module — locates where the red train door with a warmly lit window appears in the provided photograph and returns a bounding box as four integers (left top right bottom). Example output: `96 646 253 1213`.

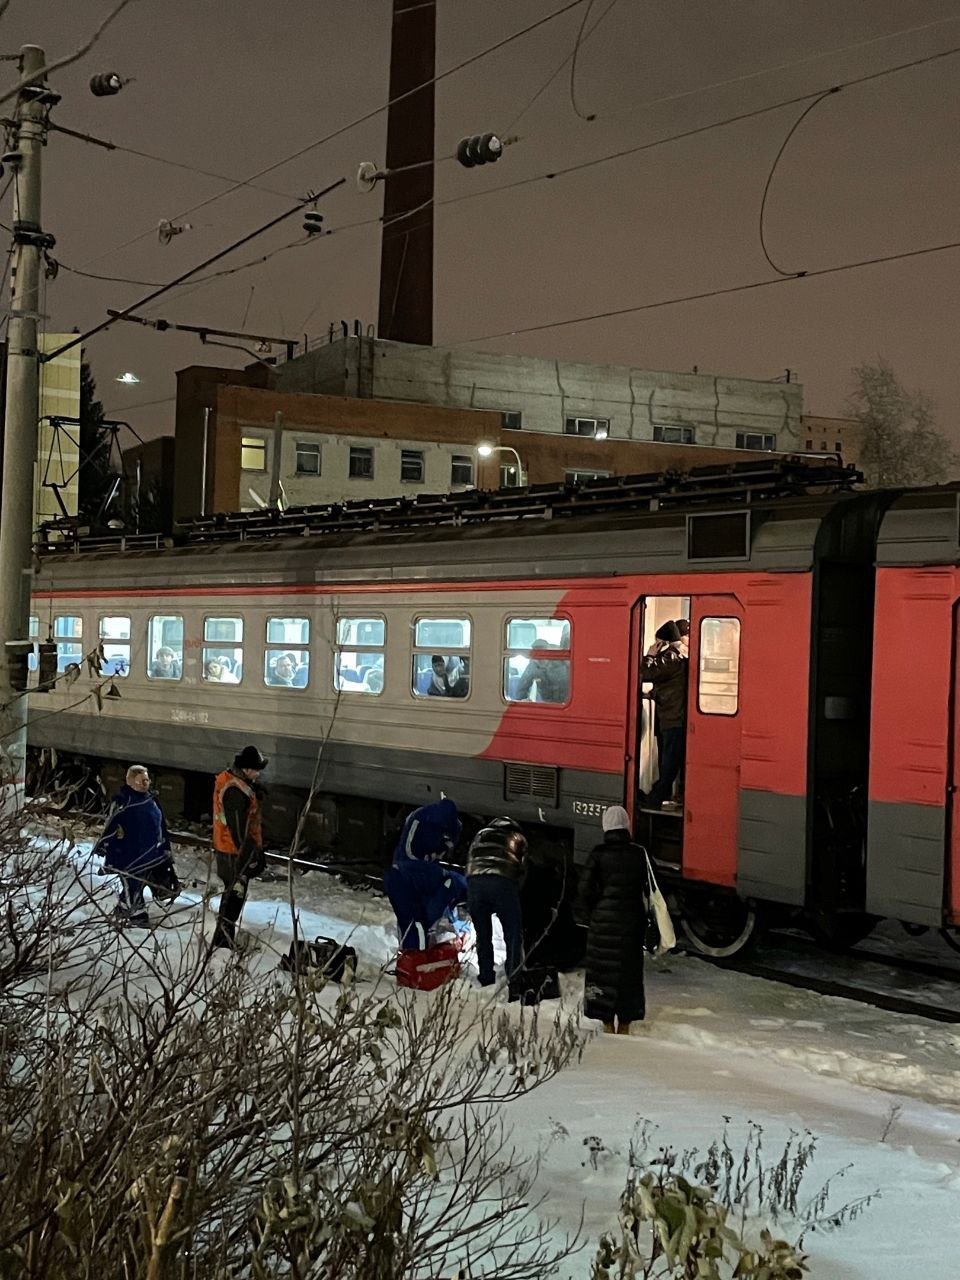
682 595 744 888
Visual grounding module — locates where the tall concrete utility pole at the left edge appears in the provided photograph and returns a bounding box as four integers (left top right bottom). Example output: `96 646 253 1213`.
0 45 46 806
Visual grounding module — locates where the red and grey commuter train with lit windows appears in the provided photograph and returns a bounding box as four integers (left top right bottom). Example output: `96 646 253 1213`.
29 458 960 956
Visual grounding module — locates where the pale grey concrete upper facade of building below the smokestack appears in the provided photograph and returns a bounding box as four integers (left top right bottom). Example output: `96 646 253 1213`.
275 335 803 453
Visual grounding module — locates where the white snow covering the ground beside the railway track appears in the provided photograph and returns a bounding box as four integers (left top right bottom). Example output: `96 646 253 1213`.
47 844 960 1280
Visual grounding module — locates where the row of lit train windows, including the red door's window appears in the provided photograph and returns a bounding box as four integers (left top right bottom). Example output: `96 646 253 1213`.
31 613 740 716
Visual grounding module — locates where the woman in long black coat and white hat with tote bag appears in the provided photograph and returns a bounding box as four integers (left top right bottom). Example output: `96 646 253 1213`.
579 805 649 1036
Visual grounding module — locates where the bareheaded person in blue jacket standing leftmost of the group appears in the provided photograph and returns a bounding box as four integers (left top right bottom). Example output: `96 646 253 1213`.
93 764 180 929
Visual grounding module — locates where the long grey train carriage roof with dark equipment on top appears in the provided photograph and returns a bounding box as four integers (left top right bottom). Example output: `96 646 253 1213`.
37 457 860 590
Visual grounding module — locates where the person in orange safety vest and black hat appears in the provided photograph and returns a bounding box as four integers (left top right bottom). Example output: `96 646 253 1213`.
211 746 268 947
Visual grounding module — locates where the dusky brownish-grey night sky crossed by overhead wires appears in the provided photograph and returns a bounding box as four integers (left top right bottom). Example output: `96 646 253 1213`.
7 0 960 436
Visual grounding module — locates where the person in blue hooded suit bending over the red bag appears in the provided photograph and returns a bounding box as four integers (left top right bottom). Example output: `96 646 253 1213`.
384 796 467 951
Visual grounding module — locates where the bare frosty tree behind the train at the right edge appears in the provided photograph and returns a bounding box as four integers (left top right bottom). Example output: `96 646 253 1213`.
850 356 960 489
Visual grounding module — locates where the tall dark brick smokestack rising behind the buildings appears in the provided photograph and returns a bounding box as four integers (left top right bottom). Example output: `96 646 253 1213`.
378 0 436 346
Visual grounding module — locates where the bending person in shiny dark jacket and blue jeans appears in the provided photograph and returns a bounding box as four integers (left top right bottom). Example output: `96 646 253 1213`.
467 818 526 995
